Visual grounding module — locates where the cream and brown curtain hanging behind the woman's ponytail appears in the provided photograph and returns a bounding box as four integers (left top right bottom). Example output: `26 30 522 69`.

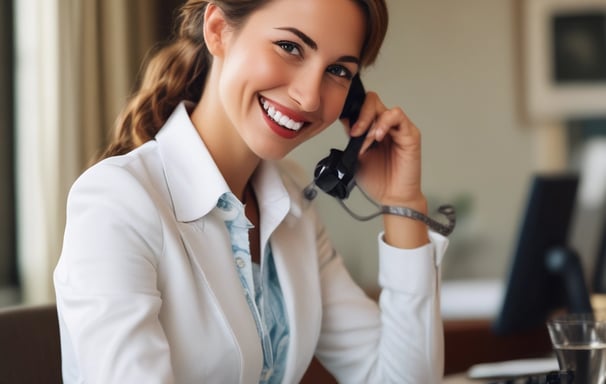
15 0 179 303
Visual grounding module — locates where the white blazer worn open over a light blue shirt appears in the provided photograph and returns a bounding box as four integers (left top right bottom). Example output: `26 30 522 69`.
54 103 446 384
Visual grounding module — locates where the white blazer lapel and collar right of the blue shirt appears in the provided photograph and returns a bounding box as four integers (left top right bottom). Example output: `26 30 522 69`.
255 162 322 383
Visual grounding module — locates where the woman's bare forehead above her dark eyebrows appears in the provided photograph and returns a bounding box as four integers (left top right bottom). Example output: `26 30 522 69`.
247 0 366 56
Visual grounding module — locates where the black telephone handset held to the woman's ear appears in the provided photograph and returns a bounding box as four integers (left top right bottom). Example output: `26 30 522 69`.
308 75 366 200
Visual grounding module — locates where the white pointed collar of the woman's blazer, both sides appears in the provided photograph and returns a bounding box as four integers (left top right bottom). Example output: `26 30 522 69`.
156 102 302 224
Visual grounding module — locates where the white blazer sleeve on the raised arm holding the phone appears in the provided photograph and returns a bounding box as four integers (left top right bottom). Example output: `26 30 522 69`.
316 213 447 384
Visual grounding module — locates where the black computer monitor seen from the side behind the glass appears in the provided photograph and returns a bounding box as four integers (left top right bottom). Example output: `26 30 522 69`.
493 174 589 334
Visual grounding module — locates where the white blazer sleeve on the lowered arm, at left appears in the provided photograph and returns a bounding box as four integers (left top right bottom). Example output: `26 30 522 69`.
54 164 174 384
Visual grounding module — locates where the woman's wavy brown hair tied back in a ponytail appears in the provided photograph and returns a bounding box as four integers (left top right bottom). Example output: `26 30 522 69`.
101 0 388 158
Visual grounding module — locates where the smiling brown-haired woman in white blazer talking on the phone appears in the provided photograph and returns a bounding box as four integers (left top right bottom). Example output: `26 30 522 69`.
54 0 447 383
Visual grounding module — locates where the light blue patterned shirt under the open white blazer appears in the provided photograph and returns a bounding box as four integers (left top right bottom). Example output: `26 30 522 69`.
217 192 289 384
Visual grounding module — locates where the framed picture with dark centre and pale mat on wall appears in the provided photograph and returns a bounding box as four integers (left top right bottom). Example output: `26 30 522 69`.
522 0 606 122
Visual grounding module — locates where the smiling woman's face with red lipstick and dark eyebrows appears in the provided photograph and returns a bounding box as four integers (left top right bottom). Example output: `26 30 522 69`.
218 0 365 159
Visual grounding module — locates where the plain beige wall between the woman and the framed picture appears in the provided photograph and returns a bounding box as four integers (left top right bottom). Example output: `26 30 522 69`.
291 0 536 286
